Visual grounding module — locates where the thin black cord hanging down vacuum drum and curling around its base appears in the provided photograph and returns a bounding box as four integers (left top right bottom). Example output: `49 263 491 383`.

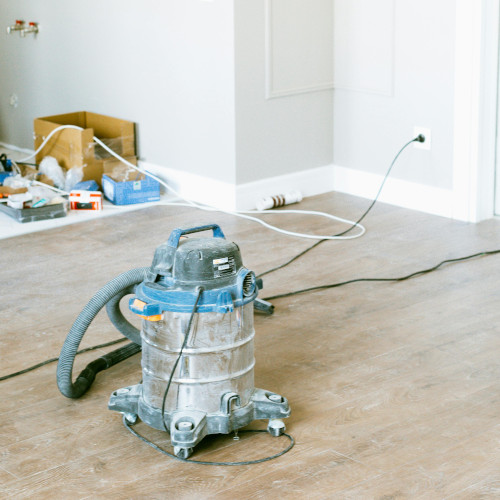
122 287 295 465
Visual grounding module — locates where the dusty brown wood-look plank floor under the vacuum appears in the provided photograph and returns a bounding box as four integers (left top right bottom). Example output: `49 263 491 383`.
0 193 500 499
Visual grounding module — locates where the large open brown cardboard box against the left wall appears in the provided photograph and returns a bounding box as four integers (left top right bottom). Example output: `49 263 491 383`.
34 111 135 185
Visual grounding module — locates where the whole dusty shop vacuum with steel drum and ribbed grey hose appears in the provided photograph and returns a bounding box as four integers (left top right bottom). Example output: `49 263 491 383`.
57 224 290 459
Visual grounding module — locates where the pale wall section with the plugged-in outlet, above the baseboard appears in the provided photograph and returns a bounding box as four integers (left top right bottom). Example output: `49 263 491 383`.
333 0 456 189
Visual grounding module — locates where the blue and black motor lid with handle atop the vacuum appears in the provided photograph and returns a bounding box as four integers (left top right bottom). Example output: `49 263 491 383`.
129 224 257 319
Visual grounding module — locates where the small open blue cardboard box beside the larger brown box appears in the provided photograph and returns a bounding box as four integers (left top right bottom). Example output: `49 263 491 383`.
102 157 160 205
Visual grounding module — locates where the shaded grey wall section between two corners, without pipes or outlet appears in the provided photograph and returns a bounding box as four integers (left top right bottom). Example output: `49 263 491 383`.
235 0 333 184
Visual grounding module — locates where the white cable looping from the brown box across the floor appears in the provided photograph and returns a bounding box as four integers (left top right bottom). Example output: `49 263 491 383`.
19 125 366 240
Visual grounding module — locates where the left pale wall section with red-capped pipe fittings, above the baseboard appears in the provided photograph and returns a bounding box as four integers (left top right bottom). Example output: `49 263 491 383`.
0 0 236 182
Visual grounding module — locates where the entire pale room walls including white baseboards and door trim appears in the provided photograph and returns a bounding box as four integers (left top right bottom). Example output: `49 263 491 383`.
0 0 498 220
